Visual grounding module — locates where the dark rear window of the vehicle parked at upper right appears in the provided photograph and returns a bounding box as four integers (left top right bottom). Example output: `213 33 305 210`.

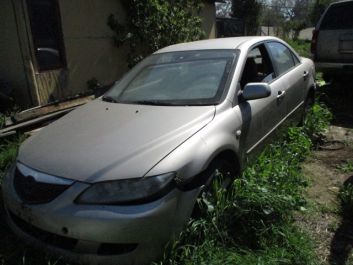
320 2 353 30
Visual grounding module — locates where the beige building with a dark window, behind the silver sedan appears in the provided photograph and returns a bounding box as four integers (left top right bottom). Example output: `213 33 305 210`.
0 0 216 108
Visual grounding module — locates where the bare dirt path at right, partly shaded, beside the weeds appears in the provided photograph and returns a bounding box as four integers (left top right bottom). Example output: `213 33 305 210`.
297 80 353 265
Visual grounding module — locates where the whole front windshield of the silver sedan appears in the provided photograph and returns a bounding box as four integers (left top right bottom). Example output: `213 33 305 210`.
103 50 237 105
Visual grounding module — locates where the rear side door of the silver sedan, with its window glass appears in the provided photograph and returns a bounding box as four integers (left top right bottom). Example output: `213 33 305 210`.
266 41 310 123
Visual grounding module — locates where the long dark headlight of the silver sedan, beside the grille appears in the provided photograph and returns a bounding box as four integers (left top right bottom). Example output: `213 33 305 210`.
75 173 175 205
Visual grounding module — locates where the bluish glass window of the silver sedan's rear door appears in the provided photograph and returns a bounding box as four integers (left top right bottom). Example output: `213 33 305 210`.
268 42 295 75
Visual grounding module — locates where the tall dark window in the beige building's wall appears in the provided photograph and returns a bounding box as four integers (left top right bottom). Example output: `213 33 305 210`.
27 0 66 71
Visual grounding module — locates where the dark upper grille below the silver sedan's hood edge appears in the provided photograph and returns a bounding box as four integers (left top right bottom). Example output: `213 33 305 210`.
14 168 69 204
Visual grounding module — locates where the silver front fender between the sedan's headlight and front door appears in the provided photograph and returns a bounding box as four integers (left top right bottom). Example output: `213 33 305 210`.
146 102 241 182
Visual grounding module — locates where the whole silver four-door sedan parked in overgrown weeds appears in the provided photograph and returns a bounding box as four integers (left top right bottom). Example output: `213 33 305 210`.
3 37 315 264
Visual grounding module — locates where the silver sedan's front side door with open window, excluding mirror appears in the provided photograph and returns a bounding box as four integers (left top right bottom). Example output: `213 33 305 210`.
238 44 285 158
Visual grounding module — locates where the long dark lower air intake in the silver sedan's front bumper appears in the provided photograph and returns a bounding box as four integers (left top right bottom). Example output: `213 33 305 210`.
9 208 78 250
